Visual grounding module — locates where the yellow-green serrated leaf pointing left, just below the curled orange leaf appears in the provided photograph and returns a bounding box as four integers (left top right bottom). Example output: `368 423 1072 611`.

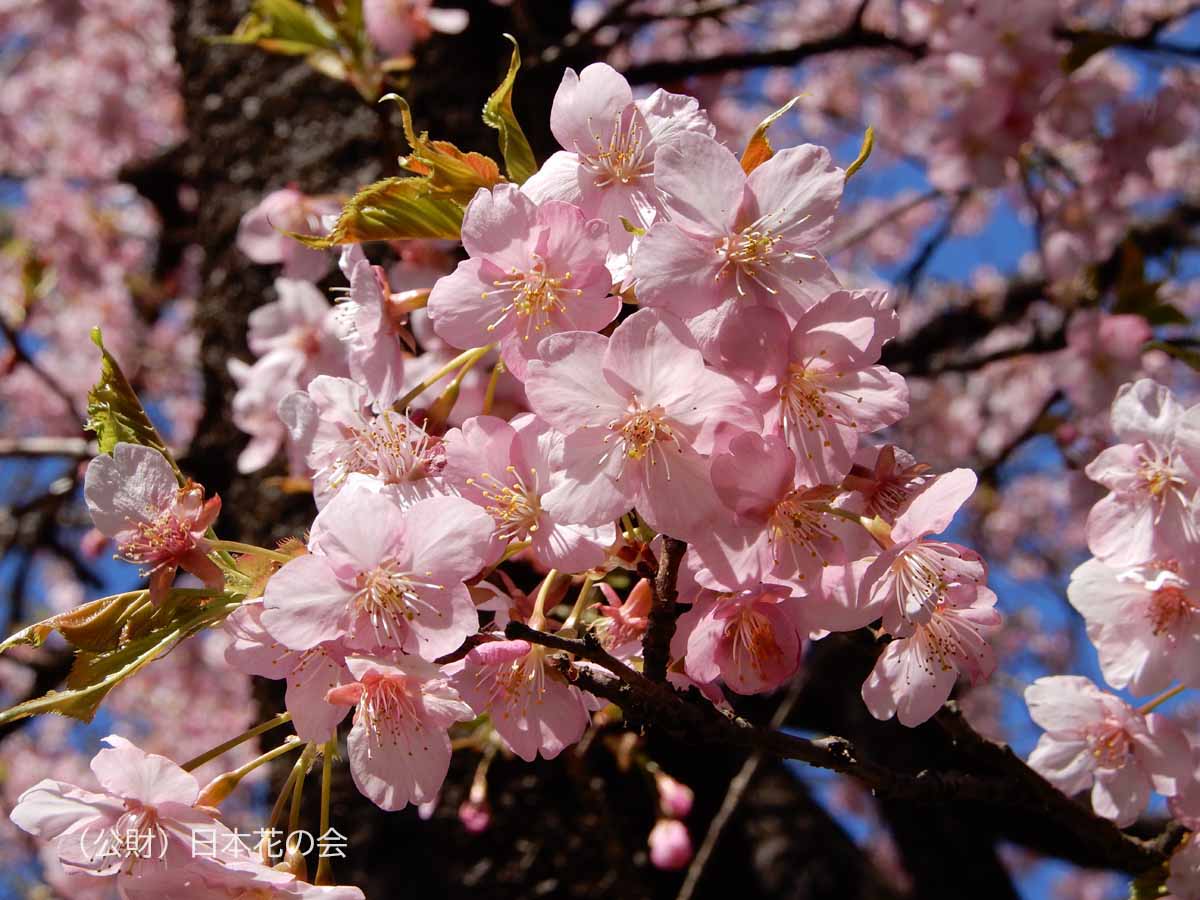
287 176 462 250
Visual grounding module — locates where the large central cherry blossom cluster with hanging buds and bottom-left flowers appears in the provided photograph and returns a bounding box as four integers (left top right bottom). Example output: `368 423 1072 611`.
13 64 1000 896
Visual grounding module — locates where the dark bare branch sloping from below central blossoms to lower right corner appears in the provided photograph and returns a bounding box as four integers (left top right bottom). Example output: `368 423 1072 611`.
505 622 1165 874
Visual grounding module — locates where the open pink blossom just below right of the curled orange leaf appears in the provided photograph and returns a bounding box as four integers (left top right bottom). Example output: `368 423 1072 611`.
428 184 620 378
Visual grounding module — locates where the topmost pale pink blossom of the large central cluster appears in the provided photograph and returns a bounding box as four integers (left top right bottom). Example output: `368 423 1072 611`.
522 62 714 281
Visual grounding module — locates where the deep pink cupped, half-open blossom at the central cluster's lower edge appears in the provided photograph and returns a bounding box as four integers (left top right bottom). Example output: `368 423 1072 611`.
671 584 808 694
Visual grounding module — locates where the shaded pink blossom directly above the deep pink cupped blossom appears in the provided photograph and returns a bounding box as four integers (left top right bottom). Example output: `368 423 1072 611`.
692 433 863 590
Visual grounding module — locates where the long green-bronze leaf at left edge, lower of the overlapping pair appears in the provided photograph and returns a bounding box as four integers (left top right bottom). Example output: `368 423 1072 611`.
0 595 241 725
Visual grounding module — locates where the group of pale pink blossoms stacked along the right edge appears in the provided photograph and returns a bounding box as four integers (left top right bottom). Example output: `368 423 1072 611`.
1025 379 1200 896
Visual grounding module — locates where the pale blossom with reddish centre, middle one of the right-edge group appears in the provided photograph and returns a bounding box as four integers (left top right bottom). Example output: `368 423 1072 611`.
1067 559 1200 694
